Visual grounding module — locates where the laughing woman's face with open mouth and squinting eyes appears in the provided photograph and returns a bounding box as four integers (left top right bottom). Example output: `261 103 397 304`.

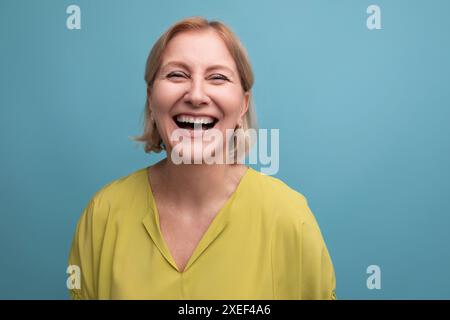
147 30 249 162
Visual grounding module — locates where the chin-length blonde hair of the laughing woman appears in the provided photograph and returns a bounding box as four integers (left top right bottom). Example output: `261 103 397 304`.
133 17 257 154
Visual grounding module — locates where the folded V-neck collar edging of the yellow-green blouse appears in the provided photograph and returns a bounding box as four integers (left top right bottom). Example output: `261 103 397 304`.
142 167 253 273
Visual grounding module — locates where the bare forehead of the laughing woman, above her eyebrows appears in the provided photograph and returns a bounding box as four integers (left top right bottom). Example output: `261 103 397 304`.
162 30 236 70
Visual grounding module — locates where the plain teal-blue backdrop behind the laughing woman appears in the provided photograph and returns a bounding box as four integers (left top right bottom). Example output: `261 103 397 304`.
0 0 450 299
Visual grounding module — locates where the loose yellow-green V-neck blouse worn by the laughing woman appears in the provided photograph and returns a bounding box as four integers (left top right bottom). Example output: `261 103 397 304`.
69 168 336 299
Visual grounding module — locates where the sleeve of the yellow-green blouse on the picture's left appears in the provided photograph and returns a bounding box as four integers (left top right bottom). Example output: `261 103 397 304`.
68 194 109 300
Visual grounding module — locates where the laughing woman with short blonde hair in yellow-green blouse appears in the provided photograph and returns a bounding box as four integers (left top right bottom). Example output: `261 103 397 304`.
69 17 336 299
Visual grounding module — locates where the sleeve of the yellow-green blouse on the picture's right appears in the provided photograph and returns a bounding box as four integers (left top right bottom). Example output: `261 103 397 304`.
271 196 336 300
